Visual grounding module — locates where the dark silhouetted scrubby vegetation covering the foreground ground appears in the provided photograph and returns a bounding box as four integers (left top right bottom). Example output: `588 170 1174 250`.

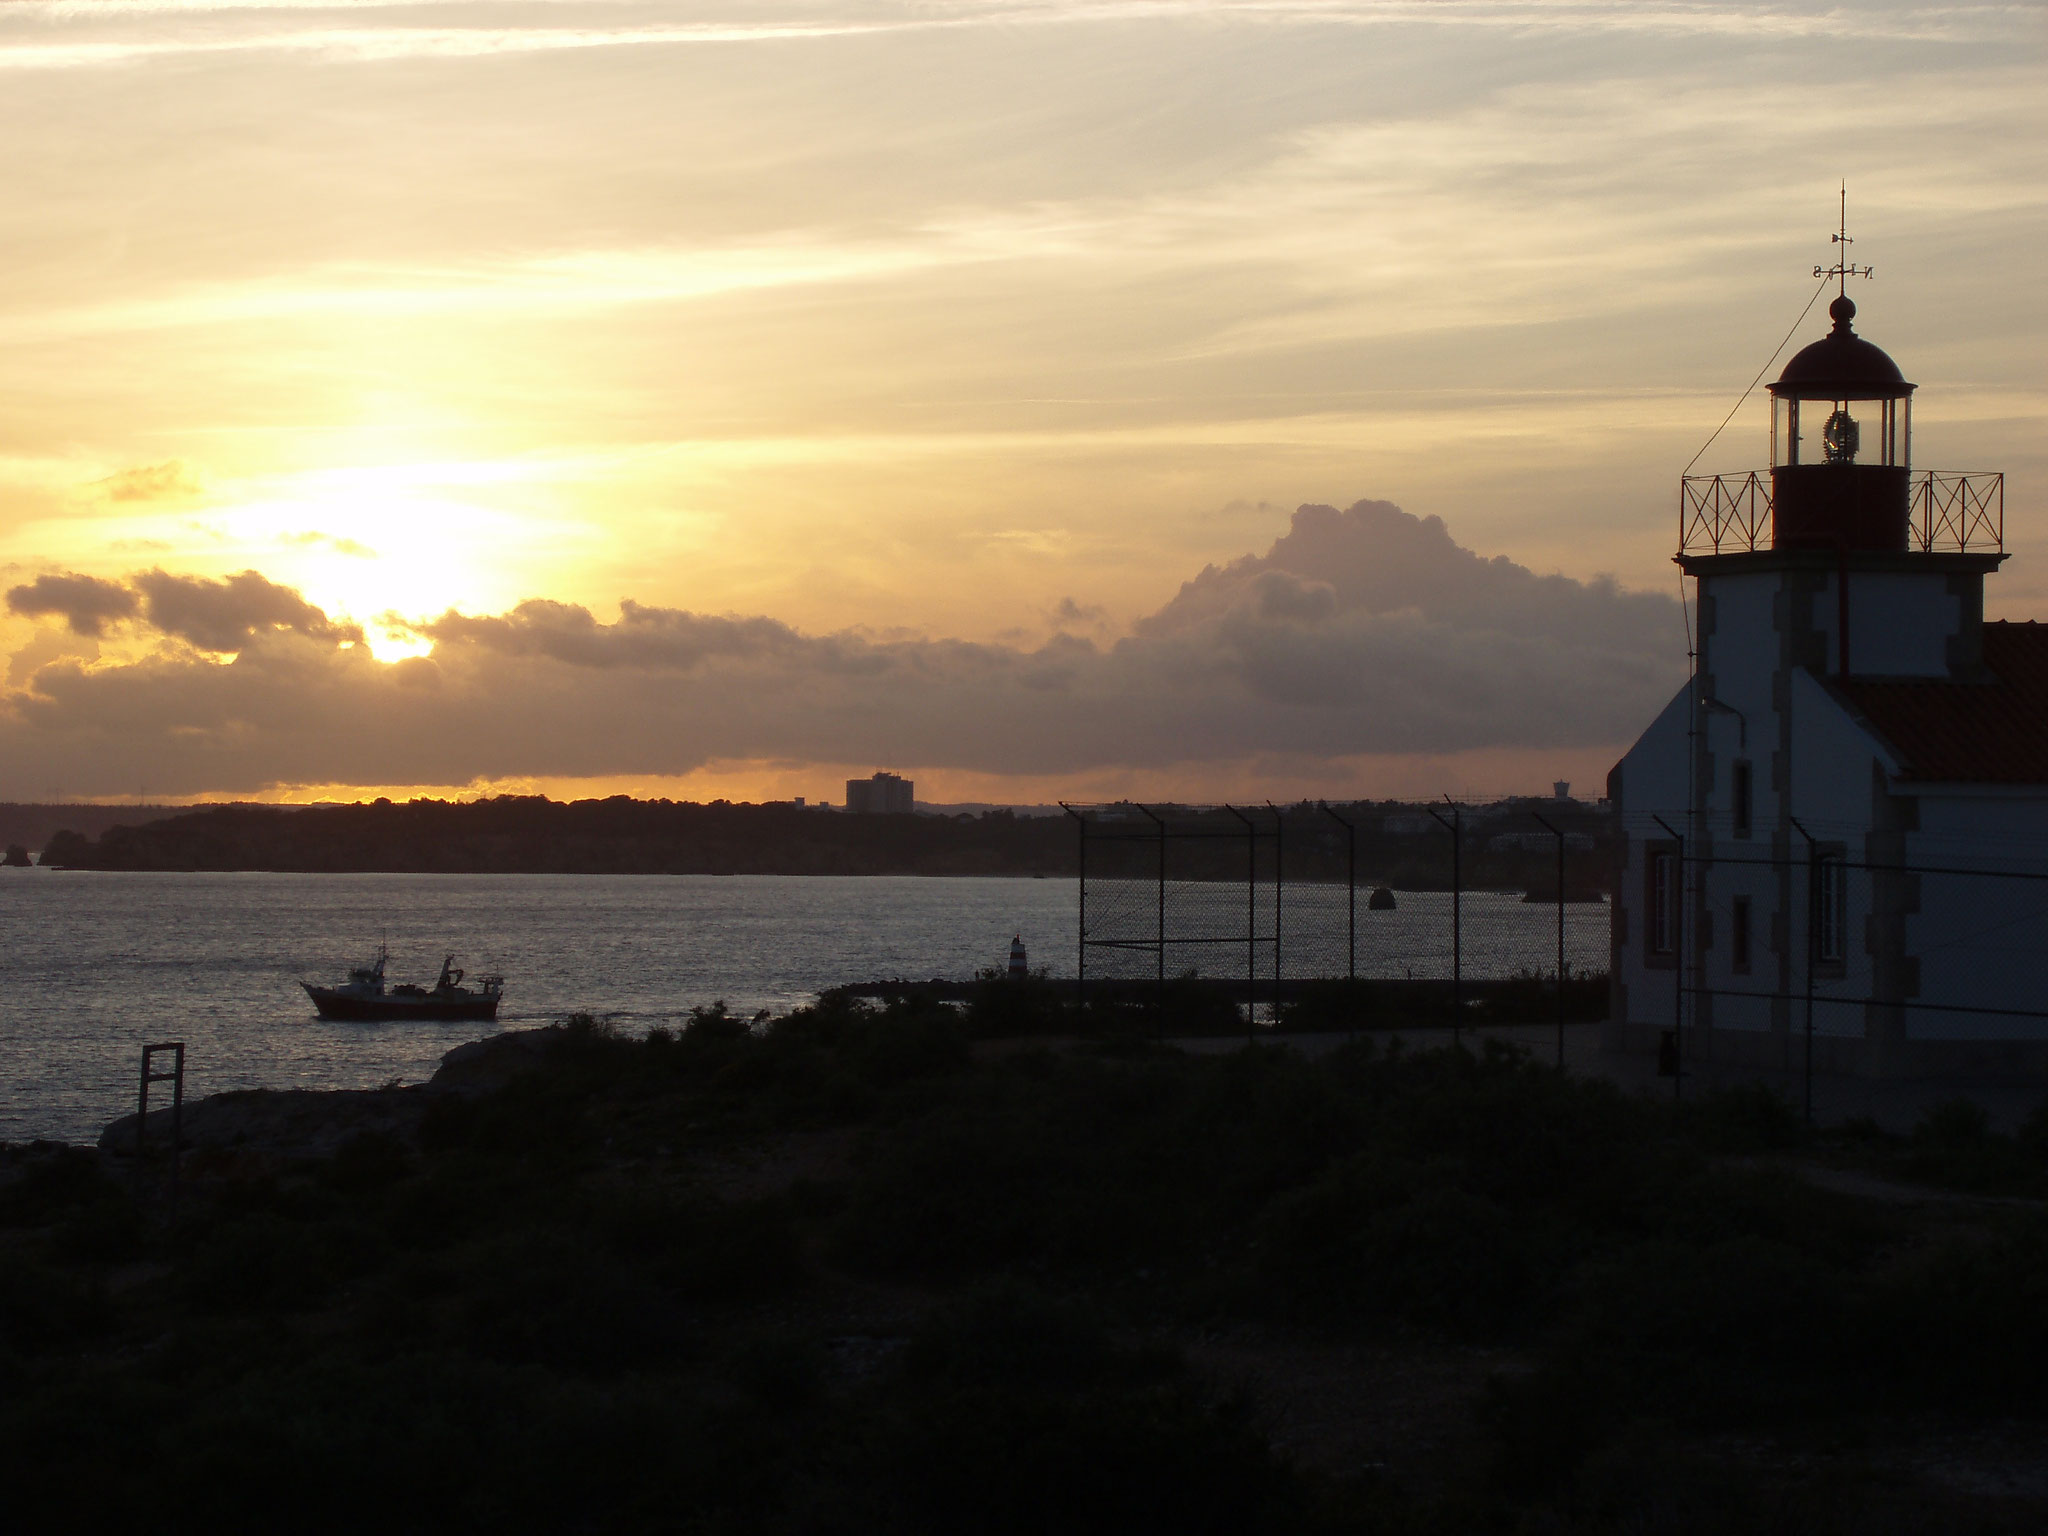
0 1003 2048 1536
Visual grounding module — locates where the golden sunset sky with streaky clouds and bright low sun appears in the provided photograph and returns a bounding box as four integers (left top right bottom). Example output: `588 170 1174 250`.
0 0 2048 801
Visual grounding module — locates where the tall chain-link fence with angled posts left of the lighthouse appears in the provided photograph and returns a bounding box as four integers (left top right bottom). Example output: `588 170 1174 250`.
1067 801 1612 1018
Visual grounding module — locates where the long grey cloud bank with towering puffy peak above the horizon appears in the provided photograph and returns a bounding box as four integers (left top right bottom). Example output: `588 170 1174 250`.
0 502 1683 793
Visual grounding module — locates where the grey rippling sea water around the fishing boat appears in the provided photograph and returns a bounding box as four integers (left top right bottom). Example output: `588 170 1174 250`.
0 868 1608 1143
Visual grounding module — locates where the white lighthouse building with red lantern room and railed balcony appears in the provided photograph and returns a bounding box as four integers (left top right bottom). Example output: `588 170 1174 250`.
1608 268 2048 1077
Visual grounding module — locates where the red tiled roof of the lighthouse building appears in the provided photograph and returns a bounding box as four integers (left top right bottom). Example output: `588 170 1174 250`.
1839 623 2048 784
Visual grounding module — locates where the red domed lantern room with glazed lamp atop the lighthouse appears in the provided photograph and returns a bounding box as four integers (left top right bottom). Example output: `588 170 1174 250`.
1772 295 1913 551
